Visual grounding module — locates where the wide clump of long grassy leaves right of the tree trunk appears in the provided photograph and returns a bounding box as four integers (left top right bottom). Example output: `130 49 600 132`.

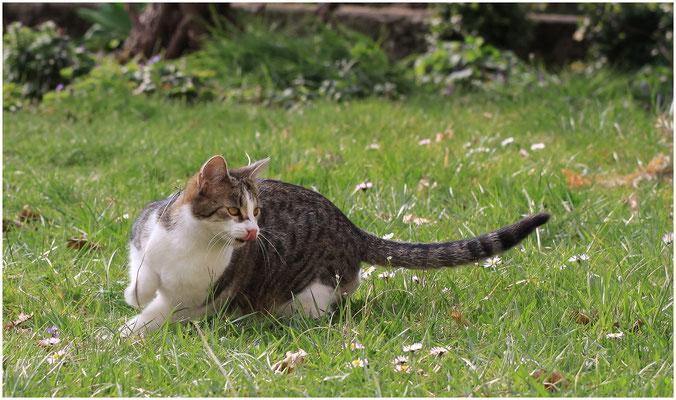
192 18 407 102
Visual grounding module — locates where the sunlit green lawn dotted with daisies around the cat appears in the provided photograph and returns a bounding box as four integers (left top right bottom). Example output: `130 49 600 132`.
3 72 673 397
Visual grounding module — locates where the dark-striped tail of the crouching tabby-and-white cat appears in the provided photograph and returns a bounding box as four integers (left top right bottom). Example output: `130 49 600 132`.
362 211 550 269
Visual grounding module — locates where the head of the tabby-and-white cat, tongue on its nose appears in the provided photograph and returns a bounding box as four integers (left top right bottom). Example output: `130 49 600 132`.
186 155 270 247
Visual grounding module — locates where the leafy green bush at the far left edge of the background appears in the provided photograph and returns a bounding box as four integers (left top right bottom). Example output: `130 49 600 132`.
3 21 94 99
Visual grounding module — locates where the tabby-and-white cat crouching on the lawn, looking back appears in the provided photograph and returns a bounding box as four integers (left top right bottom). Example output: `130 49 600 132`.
120 156 550 336
